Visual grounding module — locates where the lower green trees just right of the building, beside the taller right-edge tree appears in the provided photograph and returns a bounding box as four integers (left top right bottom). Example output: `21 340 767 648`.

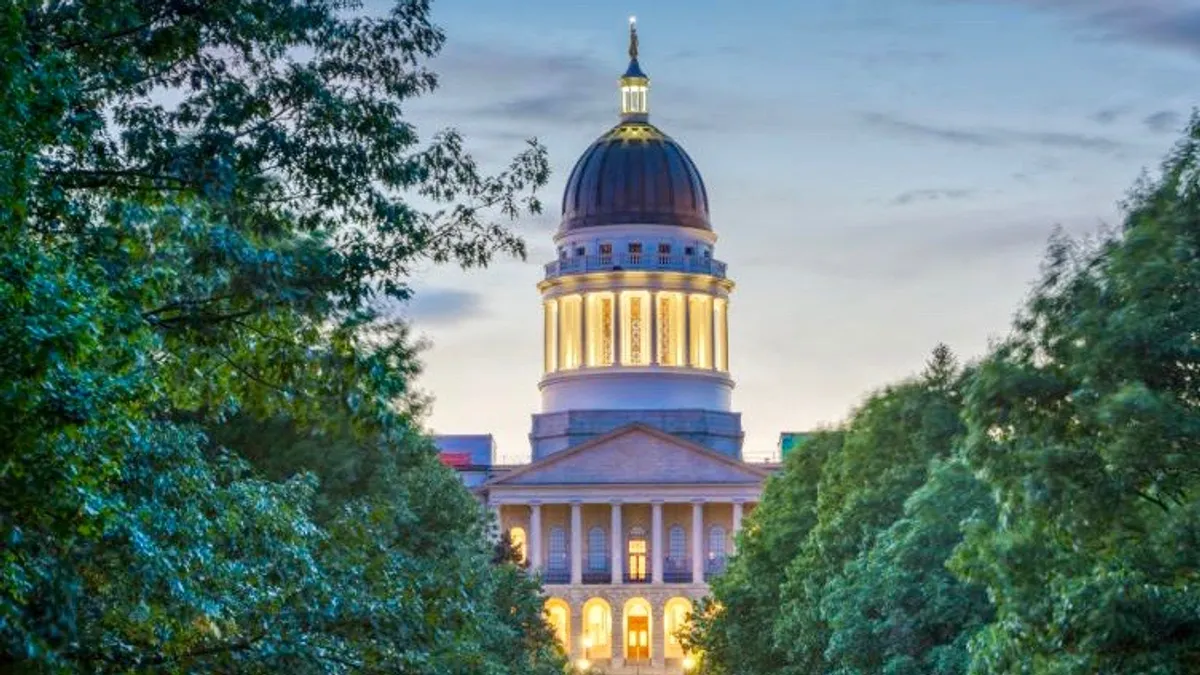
691 346 989 674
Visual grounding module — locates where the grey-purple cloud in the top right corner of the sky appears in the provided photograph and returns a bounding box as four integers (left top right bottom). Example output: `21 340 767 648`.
986 0 1200 56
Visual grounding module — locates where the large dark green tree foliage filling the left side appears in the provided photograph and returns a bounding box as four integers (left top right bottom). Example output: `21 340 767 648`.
0 0 562 674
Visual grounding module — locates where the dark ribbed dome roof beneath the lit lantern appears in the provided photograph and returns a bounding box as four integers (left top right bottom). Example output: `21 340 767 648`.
559 120 712 232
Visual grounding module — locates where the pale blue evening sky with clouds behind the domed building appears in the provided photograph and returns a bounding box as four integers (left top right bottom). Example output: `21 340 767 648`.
393 0 1200 462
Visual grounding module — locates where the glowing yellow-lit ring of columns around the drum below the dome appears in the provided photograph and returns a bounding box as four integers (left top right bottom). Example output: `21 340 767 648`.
544 291 730 374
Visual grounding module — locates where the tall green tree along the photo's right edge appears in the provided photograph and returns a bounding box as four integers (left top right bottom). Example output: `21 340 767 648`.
954 117 1200 675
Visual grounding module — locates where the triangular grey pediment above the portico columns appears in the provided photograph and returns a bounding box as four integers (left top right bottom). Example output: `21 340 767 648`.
492 424 767 485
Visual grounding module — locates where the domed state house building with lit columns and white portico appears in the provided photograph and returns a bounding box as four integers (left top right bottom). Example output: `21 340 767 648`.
437 19 778 674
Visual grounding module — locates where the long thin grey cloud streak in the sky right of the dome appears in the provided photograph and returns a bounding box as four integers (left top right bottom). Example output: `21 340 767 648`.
862 113 1127 155
